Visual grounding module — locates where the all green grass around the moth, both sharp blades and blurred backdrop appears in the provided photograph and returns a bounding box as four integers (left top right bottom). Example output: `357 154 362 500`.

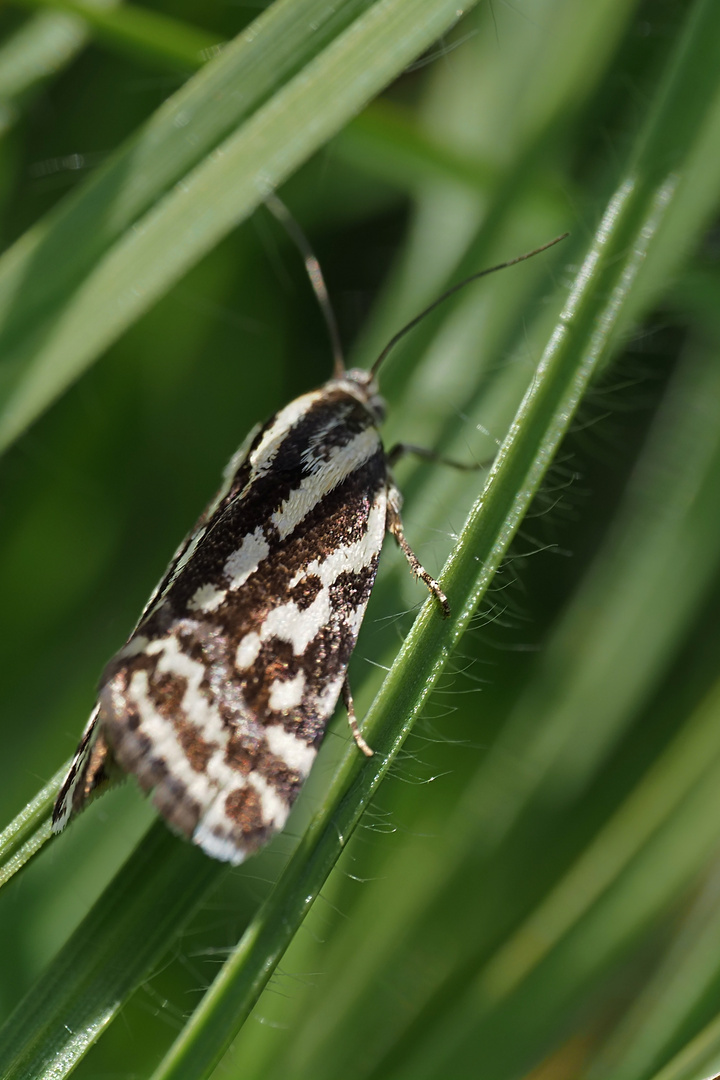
0 0 720 1080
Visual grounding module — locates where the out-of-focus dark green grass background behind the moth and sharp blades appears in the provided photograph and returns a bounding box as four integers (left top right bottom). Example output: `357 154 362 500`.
0 0 720 1080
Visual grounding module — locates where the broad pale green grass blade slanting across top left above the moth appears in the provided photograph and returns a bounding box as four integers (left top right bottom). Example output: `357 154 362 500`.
0 0 472 447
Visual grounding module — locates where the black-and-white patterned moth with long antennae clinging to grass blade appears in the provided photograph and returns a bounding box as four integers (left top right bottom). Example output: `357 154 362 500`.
53 223 556 864
